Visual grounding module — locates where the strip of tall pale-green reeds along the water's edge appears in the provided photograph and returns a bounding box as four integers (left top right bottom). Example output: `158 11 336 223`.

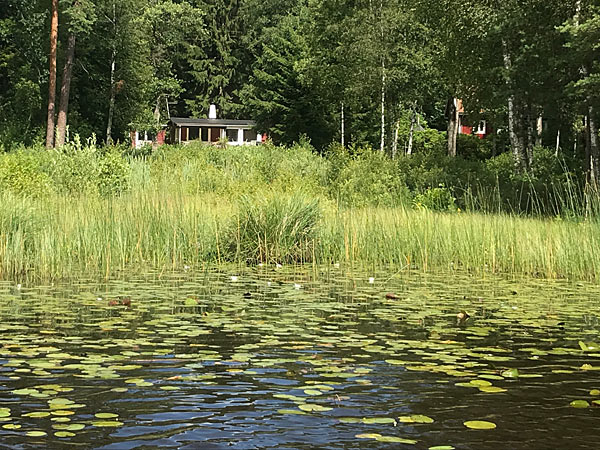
0 191 600 280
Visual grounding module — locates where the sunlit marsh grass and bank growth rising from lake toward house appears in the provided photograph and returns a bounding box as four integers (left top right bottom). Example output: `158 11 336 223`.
0 142 600 280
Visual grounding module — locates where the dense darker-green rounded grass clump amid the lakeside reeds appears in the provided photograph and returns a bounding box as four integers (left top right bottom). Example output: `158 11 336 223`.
226 193 321 263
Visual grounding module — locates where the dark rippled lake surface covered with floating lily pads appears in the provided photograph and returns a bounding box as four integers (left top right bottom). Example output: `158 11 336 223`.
0 268 600 449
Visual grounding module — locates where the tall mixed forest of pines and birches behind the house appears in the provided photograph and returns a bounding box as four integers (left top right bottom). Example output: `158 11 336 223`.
0 0 600 178
